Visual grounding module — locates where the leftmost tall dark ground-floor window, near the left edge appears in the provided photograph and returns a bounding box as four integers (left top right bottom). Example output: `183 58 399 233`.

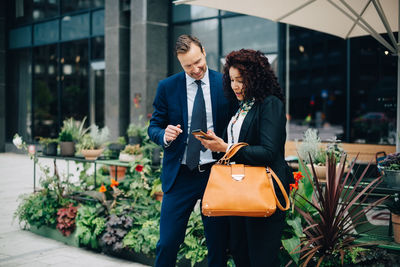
6 49 32 140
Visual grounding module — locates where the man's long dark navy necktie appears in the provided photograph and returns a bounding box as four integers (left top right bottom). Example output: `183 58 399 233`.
186 80 207 170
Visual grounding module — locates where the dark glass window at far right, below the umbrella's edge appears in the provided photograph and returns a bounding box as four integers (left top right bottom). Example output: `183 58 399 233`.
350 36 398 144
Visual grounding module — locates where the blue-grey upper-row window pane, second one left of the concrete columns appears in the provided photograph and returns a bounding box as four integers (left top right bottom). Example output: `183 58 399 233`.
61 14 90 40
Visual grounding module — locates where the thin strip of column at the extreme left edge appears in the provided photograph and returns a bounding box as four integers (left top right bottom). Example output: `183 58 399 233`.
0 1 6 152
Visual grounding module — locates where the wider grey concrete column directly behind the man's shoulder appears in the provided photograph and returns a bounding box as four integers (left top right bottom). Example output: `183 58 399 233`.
130 0 170 123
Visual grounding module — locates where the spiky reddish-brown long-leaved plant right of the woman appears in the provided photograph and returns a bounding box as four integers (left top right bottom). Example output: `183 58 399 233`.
295 154 386 266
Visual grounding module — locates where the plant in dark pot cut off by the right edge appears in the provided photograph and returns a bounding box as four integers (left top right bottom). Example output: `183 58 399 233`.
378 153 400 189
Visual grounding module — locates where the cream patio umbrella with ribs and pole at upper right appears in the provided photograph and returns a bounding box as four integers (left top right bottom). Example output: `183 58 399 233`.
174 0 400 151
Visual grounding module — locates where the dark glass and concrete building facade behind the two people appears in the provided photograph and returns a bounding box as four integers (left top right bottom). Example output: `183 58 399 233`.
0 0 397 151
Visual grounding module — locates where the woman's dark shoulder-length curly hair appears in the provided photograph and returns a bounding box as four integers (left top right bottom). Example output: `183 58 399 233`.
223 49 285 102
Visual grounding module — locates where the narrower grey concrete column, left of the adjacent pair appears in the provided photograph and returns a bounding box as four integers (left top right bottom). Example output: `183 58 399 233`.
104 0 129 139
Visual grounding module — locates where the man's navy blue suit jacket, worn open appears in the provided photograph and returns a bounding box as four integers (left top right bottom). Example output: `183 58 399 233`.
148 69 234 193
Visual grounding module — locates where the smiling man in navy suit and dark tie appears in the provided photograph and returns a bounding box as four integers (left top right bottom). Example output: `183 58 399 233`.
148 35 232 267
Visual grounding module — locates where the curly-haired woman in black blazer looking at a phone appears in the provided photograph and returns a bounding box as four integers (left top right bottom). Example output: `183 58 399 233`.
198 49 293 267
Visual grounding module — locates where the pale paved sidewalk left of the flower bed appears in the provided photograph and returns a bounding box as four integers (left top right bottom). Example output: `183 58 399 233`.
0 153 149 267
